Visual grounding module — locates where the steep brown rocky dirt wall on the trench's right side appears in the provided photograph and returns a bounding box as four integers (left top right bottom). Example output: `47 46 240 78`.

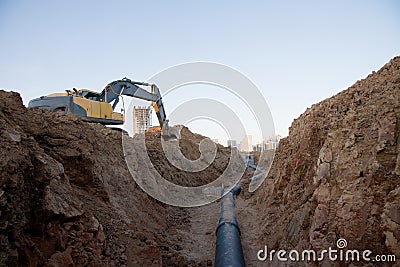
253 57 400 266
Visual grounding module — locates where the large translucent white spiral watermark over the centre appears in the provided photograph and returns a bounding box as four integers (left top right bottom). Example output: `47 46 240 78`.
122 62 275 207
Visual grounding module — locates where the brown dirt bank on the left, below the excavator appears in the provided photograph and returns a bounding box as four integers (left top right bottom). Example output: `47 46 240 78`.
0 91 228 266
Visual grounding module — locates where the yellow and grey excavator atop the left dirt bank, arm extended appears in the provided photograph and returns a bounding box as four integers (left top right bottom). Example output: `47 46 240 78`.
28 78 179 138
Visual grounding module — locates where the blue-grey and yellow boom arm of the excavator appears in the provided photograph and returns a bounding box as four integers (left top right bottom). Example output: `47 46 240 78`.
99 78 168 128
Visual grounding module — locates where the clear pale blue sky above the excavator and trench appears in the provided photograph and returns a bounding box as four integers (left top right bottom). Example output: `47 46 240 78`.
0 0 400 144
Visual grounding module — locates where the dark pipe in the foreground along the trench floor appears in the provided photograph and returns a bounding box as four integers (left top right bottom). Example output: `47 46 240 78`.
215 186 245 267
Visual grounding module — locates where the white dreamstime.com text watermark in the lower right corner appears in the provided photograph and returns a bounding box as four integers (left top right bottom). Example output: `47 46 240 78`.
257 238 396 262
